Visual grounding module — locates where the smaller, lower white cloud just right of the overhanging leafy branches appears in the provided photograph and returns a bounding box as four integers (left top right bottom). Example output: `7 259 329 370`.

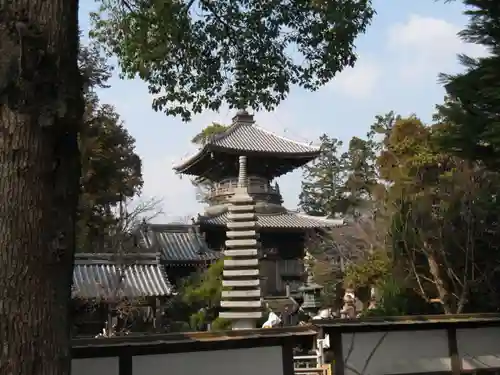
329 58 381 99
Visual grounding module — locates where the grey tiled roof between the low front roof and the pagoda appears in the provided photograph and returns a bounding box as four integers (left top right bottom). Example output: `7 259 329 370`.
141 224 220 263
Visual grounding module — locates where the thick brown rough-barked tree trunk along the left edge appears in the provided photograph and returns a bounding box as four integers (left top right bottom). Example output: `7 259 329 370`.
0 0 83 375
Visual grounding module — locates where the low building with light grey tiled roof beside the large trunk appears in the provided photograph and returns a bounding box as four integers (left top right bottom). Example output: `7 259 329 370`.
72 253 174 336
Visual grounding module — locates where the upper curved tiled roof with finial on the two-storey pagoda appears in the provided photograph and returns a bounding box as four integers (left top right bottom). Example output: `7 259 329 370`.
174 111 320 180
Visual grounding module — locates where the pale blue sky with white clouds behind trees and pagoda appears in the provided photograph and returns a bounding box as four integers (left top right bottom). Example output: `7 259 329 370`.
80 0 484 222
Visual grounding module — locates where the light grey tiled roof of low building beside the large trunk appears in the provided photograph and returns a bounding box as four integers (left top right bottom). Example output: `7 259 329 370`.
73 254 172 299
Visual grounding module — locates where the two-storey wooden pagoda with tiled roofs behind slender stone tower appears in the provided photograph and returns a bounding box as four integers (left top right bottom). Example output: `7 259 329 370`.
174 111 343 297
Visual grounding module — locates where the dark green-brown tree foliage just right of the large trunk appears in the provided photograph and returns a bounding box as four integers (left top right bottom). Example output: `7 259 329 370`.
77 47 143 251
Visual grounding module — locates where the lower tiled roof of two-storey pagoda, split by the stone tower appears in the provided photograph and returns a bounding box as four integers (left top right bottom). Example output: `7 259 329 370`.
199 211 344 229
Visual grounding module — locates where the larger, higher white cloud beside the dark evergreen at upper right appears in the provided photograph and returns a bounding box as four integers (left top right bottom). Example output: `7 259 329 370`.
388 15 485 82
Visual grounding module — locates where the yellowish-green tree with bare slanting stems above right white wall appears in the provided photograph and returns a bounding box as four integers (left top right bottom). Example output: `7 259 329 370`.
377 116 500 314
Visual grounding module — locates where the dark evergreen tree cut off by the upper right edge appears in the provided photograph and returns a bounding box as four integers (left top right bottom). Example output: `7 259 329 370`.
437 0 500 170
